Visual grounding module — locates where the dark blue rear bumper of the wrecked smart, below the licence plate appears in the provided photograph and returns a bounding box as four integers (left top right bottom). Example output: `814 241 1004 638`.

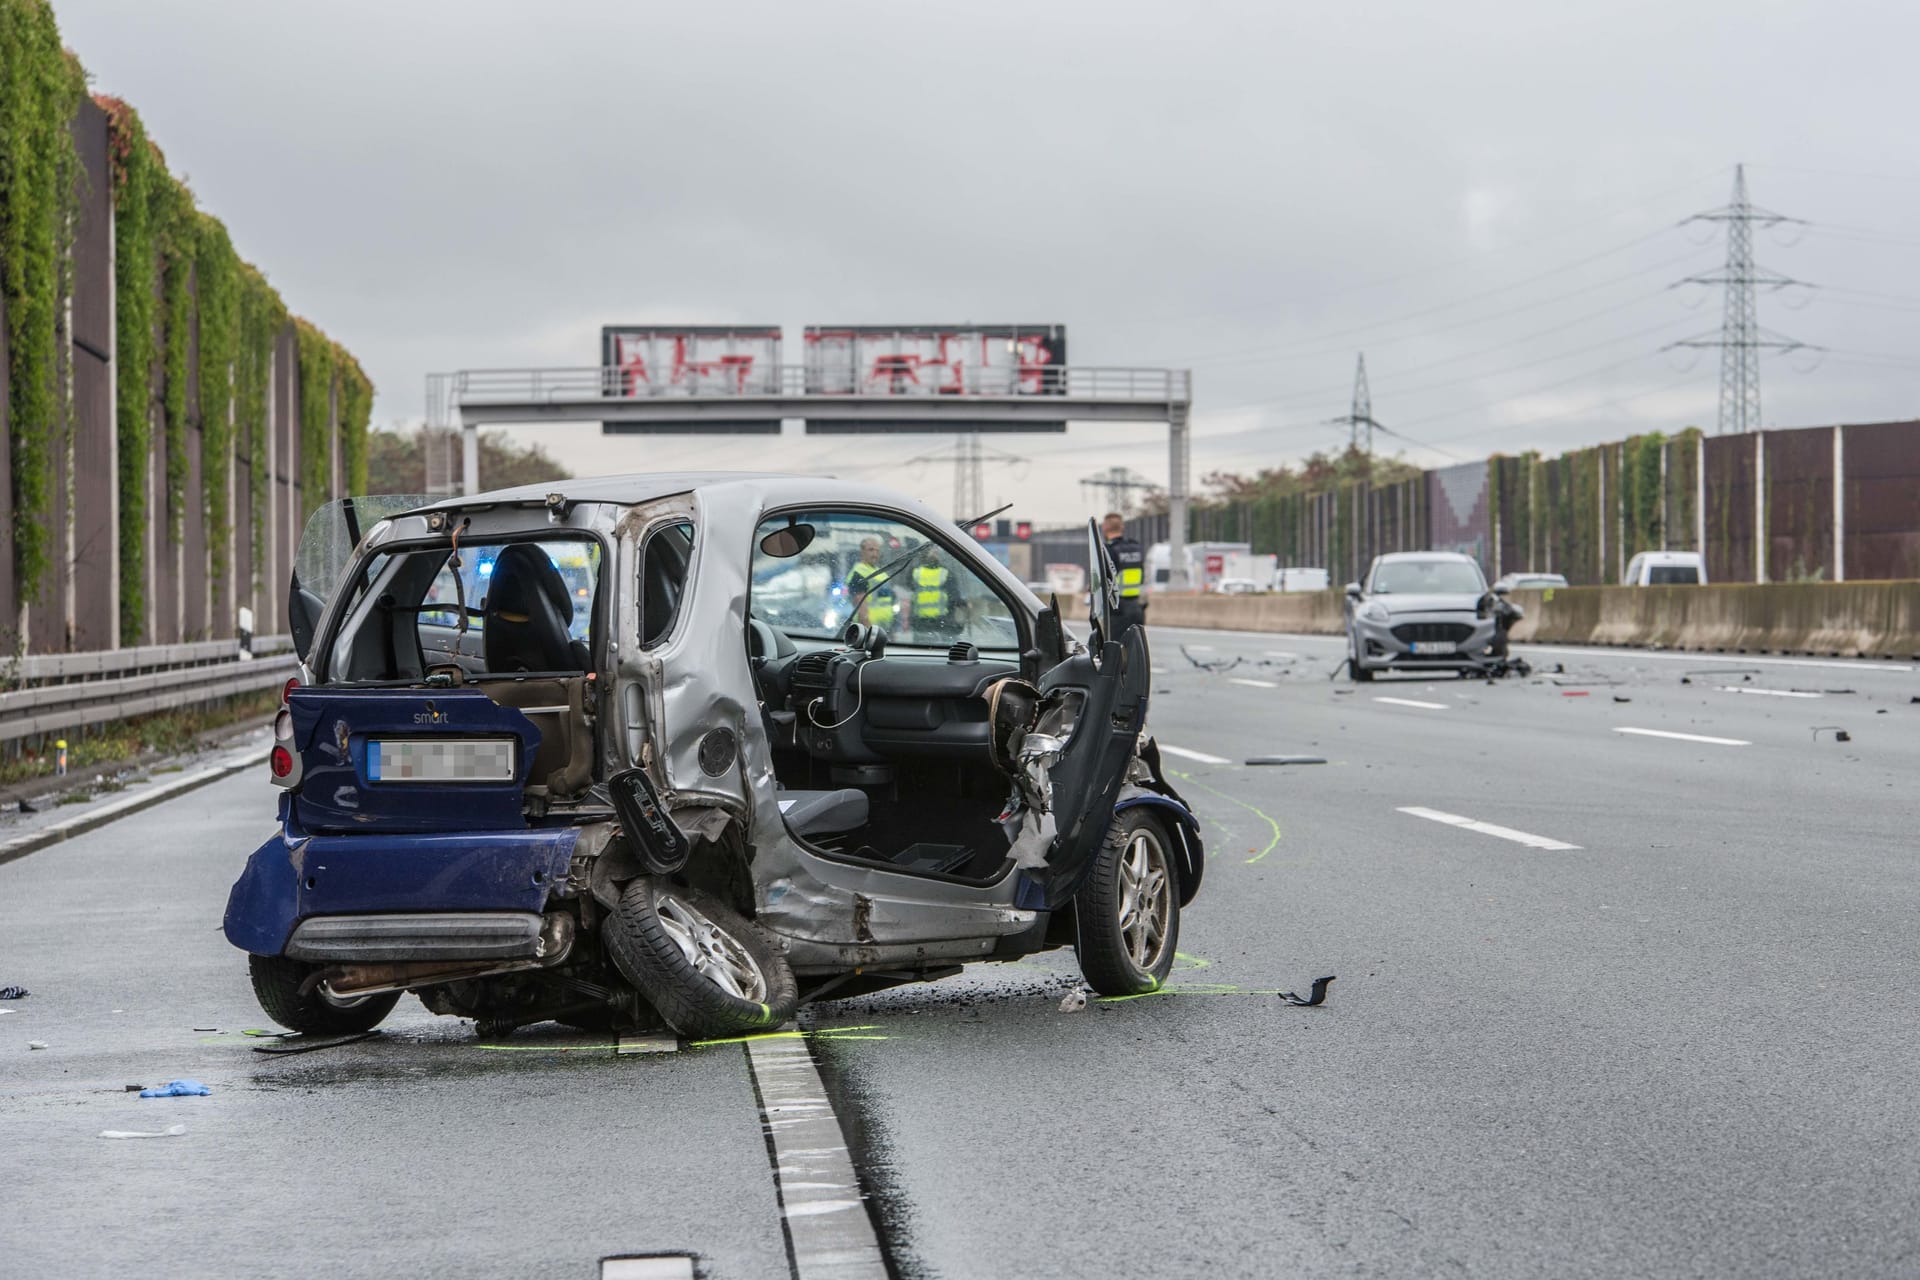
225 809 580 956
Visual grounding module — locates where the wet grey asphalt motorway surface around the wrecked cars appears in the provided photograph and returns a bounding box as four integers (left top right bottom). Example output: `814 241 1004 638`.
0 629 1920 1278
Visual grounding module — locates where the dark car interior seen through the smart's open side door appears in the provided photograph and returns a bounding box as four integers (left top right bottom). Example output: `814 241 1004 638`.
747 512 1021 881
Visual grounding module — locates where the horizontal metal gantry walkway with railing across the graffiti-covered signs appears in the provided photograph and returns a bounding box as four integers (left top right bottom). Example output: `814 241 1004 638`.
445 365 1192 405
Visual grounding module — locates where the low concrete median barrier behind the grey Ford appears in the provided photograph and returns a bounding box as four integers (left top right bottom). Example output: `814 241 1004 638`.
1090 581 1920 658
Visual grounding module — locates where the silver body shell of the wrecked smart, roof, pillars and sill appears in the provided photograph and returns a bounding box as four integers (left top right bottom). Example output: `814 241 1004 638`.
309 472 1167 975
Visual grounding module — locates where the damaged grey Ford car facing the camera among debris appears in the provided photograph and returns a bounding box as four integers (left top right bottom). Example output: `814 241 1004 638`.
1346 551 1498 674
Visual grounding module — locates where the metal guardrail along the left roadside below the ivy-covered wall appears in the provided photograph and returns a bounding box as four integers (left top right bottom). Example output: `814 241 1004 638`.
0 635 300 743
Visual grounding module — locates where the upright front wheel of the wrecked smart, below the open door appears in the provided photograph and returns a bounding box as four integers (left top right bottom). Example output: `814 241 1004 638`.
1073 808 1181 996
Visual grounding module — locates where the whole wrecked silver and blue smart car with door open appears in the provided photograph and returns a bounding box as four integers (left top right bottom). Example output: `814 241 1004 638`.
225 474 1204 1036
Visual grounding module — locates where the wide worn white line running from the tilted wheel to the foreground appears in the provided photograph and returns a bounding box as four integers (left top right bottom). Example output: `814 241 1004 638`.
747 1034 887 1280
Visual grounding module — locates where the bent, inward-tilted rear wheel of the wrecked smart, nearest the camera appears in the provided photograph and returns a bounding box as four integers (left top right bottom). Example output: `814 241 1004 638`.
601 875 801 1038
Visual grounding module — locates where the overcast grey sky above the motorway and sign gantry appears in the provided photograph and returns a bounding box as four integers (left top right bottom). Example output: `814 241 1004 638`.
54 0 1920 520
